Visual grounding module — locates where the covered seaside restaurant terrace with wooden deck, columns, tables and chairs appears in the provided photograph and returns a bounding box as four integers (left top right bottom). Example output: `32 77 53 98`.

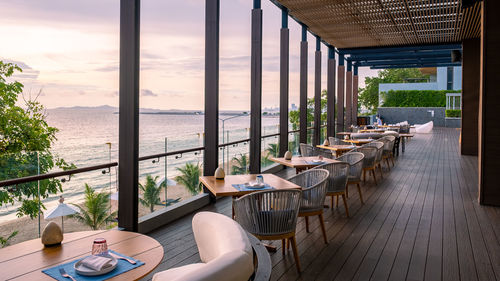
0 0 500 281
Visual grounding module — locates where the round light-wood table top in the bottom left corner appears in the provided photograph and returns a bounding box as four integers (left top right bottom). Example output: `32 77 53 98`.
0 230 163 280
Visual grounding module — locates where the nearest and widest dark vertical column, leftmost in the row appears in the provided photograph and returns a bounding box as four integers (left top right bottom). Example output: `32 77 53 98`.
118 0 141 231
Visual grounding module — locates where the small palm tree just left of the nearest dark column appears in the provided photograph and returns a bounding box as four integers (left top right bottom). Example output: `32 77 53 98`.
70 184 116 230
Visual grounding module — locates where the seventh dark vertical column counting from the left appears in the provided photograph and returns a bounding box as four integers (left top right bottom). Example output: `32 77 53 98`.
326 46 336 137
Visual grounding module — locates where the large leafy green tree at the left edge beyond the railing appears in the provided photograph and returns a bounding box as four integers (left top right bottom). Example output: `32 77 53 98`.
0 61 74 218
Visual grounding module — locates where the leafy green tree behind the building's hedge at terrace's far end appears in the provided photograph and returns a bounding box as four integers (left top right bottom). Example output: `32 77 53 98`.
358 68 429 113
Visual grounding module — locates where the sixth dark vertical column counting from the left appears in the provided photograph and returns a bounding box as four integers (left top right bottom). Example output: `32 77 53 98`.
313 37 321 146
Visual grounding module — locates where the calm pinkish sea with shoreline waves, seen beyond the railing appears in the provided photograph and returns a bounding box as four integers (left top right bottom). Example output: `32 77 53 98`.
0 107 279 223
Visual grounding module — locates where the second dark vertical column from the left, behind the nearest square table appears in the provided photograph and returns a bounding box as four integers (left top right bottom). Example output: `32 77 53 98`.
203 0 220 176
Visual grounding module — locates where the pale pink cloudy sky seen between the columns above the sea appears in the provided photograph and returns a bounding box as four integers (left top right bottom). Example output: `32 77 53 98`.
0 0 376 110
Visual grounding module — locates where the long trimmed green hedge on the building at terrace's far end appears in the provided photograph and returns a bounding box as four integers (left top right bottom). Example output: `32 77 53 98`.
381 90 460 107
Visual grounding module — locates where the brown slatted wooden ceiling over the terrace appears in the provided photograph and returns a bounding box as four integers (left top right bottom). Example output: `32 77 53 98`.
275 0 480 48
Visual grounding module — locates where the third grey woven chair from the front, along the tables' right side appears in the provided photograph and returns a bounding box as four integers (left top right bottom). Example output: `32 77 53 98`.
317 162 349 217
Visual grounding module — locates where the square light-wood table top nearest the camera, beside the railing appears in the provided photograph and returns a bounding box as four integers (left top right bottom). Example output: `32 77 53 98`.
200 174 300 196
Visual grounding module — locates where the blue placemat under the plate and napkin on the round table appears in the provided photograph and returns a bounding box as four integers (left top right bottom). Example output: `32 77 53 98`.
42 250 144 281
